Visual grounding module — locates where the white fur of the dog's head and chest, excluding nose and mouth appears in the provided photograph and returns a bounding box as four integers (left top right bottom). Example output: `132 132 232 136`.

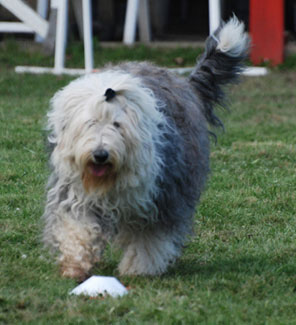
48 72 165 223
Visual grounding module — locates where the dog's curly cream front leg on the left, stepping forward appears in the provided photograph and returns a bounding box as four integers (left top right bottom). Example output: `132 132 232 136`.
44 204 105 281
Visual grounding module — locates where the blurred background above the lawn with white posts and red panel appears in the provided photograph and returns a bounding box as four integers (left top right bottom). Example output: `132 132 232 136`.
0 0 296 71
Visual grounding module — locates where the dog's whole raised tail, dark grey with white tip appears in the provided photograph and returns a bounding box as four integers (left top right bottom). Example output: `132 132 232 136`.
189 16 250 126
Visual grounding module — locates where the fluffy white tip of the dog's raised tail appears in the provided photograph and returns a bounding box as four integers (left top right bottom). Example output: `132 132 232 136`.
217 16 249 57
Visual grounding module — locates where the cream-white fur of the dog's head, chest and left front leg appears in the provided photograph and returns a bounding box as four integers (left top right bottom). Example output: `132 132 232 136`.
44 71 172 277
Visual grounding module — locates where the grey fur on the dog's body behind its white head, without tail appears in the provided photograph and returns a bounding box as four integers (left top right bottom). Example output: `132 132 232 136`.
118 62 209 239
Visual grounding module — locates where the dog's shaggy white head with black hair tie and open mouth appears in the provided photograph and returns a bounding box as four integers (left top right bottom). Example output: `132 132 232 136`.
48 71 164 193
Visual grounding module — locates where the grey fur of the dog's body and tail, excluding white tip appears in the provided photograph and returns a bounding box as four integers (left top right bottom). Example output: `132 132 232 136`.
111 24 249 256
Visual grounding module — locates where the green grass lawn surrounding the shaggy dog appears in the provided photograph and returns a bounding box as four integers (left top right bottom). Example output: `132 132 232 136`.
0 42 296 324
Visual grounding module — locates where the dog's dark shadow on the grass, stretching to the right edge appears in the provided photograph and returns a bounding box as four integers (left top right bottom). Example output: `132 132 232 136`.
85 251 296 283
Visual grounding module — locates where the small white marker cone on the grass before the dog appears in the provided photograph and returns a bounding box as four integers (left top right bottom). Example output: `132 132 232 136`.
70 275 128 297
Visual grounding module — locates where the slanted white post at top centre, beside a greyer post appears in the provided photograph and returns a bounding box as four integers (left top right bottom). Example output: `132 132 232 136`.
123 0 139 45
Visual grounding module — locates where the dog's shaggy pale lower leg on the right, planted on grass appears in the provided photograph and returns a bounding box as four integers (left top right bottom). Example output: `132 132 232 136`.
117 230 181 275
